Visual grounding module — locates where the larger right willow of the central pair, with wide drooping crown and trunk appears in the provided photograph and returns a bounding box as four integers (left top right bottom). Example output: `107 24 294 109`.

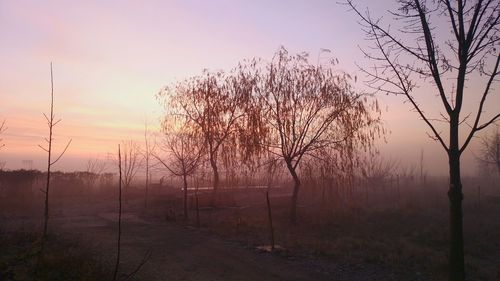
254 48 381 222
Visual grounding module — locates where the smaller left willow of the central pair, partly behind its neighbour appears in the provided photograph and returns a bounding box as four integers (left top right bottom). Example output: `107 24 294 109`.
158 70 244 196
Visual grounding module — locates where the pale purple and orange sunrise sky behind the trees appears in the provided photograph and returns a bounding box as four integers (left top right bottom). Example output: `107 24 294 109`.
0 0 500 175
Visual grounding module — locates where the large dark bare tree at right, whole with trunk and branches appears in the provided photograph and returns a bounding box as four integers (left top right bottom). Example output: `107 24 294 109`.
347 0 500 281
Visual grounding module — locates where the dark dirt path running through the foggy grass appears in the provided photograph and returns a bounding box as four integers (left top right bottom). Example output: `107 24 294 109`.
1 200 410 281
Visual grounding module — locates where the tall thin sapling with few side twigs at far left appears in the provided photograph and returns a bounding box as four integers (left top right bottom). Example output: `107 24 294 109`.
38 63 71 256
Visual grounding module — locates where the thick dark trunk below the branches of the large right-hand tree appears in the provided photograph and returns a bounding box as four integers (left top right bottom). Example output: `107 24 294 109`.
448 116 465 281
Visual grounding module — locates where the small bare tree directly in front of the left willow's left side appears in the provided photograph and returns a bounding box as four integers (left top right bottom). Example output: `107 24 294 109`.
153 121 204 220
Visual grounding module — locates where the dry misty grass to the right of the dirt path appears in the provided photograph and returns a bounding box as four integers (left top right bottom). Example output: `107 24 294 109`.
141 178 500 281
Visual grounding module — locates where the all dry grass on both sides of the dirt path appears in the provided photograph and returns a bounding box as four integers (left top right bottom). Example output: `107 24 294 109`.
0 174 500 281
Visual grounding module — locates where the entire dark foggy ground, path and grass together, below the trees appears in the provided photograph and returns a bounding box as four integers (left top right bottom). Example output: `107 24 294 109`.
0 172 500 280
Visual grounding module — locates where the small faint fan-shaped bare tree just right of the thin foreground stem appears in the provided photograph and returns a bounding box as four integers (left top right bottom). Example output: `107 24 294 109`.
121 140 142 189
